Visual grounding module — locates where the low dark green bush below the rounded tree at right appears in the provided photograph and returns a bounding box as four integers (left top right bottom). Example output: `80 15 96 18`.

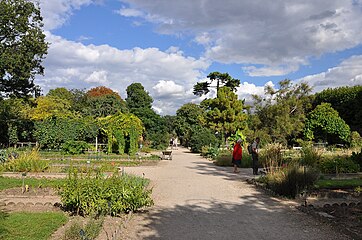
319 157 359 174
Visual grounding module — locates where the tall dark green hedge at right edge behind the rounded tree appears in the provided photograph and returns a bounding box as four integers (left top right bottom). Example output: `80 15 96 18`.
314 85 362 134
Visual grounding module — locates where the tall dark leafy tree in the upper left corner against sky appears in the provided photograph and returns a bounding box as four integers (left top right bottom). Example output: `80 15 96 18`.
0 0 48 98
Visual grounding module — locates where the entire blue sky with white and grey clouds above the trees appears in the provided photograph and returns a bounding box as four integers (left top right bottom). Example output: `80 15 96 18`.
35 0 362 115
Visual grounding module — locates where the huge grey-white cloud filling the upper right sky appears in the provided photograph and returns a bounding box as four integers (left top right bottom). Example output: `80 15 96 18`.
122 0 362 76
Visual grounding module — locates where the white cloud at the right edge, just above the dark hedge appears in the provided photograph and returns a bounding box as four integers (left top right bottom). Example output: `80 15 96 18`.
297 55 362 92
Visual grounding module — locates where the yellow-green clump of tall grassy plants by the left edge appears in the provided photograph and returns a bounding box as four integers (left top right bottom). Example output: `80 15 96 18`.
0 148 49 172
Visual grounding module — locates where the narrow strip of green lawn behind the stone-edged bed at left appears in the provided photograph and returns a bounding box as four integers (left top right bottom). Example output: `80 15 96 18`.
0 177 65 191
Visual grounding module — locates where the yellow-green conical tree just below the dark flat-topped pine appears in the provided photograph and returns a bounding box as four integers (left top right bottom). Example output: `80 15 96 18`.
200 87 247 141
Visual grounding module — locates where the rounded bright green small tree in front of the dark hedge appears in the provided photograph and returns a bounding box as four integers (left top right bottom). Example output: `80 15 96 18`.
304 103 351 143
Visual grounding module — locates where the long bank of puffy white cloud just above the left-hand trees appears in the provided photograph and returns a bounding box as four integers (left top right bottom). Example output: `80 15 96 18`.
36 32 210 114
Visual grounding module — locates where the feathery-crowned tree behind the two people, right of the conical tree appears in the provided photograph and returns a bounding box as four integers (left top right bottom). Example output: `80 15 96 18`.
250 79 311 144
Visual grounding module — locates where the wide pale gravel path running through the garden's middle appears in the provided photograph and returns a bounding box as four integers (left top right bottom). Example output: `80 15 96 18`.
118 148 348 240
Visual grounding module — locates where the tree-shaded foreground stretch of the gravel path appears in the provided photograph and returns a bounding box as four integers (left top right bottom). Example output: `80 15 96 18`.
128 193 349 240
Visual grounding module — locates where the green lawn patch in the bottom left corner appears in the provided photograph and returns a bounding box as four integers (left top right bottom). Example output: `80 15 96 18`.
0 212 68 240
